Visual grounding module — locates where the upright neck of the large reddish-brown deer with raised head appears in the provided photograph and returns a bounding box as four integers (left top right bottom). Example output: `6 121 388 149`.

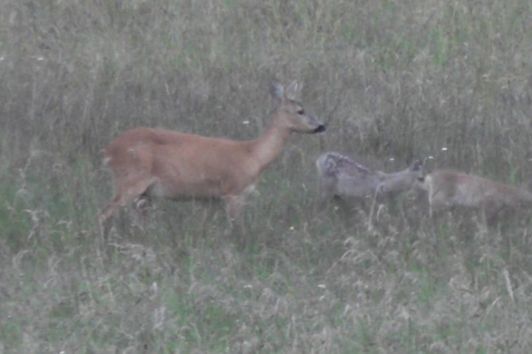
251 119 290 171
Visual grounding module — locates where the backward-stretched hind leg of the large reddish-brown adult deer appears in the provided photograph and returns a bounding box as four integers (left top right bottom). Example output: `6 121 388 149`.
98 178 155 234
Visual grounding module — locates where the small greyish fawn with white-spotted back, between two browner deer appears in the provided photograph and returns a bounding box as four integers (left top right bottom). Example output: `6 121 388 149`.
316 152 423 225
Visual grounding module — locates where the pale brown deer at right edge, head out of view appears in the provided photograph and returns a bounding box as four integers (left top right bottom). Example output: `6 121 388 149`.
421 170 532 223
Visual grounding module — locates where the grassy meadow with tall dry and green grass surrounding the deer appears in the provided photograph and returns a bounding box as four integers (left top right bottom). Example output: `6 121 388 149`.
0 0 532 354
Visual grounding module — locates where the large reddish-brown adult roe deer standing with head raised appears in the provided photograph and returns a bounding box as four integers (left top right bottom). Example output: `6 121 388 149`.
99 82 325 230
